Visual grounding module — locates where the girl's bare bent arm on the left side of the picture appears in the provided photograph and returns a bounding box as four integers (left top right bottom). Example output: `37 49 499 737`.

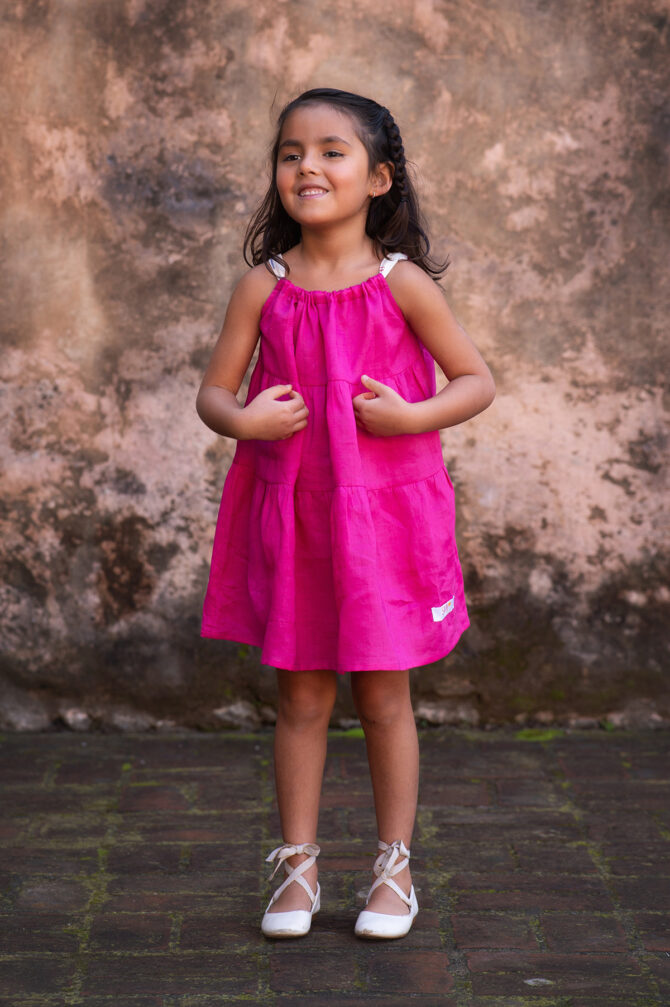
195 266 307 440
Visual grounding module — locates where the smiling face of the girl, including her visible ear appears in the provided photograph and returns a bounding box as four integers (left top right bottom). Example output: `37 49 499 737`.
275 105 390 228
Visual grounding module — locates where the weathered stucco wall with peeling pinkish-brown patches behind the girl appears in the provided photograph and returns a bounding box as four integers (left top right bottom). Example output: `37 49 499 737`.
0 0 670 729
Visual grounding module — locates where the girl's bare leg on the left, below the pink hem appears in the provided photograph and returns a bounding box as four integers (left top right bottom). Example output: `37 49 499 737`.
270 670 337 912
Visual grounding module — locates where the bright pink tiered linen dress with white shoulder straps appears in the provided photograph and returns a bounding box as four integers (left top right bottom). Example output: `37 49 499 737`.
202 253 470 673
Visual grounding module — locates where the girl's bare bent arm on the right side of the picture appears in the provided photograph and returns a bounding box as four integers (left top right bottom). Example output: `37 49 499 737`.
354 262 496 436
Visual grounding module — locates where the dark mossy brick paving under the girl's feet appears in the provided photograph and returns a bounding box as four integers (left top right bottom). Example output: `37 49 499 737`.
0 730 670 1007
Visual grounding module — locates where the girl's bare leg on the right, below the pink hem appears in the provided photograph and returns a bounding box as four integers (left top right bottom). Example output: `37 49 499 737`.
352 671 419 915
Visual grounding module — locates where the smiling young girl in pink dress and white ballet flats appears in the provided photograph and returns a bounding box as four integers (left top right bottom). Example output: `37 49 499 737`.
197 89 495 938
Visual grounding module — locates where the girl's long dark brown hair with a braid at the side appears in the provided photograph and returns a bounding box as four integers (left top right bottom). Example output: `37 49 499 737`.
244 88 448 279
